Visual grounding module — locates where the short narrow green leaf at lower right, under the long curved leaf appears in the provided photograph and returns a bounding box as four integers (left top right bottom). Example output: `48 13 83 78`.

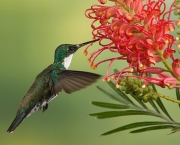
130 125 176 133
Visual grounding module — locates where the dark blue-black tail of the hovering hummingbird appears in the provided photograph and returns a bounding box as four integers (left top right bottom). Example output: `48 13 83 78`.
7 113 26 133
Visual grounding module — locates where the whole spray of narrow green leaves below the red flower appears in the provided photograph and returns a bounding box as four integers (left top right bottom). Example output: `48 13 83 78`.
90 81 180 135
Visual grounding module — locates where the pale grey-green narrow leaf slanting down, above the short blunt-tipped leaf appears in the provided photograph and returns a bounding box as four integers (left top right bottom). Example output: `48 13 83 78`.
97 85 129 104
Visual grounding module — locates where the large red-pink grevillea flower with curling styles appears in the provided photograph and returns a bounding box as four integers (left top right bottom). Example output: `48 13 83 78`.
84 0 180 88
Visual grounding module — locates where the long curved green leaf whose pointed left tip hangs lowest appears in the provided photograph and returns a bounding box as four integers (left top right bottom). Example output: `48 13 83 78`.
102 121 176 136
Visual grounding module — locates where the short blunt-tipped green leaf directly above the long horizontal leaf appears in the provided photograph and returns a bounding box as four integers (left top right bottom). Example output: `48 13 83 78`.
91 101 130 109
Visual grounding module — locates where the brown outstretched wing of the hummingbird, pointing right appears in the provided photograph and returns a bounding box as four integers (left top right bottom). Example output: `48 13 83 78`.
49 70 101 96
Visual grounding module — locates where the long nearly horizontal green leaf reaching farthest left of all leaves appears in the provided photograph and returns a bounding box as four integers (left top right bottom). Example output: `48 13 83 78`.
89 110 160 119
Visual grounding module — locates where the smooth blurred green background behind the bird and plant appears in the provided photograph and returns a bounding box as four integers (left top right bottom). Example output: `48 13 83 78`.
0 0 180 145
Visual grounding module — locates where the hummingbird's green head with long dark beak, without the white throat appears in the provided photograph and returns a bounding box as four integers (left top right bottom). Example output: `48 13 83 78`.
54 39 99 62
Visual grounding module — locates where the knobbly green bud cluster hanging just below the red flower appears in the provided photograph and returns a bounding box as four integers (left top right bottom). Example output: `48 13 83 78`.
119 77 158 103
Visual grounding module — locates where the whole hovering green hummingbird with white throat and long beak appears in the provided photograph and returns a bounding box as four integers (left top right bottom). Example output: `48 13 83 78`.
7 40 101 133
